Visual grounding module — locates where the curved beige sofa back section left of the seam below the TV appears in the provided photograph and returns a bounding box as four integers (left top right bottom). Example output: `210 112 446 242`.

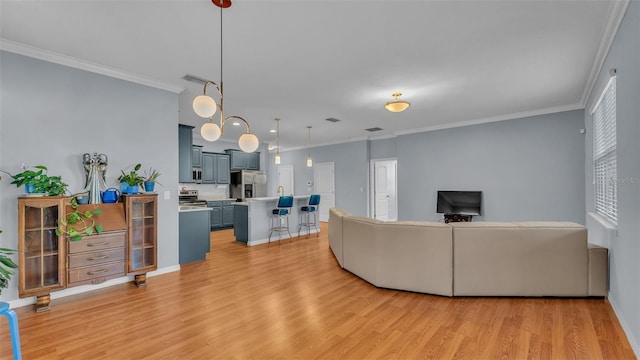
343 216 453 296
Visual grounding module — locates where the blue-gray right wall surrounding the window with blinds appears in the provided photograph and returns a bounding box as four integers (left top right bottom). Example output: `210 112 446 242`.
584 1 640 356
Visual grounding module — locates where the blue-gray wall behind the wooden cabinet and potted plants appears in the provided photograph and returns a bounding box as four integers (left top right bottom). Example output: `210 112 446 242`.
0 51 178 300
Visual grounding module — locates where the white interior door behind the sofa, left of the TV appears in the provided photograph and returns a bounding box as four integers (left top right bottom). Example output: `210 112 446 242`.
372 159 398 221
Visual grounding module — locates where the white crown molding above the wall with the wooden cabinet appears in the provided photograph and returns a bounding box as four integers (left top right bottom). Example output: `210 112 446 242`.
0 38 184 94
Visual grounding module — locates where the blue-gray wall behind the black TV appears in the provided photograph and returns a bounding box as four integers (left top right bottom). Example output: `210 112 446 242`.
397 110 584 224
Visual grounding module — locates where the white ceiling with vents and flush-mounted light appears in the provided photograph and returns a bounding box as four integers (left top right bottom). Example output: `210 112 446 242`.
0 0 621 149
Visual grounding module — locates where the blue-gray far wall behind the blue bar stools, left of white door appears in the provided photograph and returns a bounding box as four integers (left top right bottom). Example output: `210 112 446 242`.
266 140 369 216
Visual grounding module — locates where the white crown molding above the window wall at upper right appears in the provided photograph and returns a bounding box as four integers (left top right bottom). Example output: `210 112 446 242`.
580 0 631 107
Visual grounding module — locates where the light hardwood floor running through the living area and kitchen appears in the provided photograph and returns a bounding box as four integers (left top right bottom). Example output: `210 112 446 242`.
0 223 635 360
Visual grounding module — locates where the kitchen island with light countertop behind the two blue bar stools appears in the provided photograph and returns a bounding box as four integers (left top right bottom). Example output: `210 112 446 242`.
233 195 320 246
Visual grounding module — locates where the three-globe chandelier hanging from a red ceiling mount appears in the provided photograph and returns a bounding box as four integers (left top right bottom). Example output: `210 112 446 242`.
193 0 260 153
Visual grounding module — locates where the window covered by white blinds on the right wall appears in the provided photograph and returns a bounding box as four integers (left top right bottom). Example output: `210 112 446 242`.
591 76 618 224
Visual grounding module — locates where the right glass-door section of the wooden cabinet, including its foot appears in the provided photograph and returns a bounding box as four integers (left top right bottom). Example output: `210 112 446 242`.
123 194 158 287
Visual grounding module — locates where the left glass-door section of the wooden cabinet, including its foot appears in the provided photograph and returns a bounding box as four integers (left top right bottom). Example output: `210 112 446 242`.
18 196 67 312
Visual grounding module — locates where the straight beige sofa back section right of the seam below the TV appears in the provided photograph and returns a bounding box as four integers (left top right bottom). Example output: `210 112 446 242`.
450 222 588 296
